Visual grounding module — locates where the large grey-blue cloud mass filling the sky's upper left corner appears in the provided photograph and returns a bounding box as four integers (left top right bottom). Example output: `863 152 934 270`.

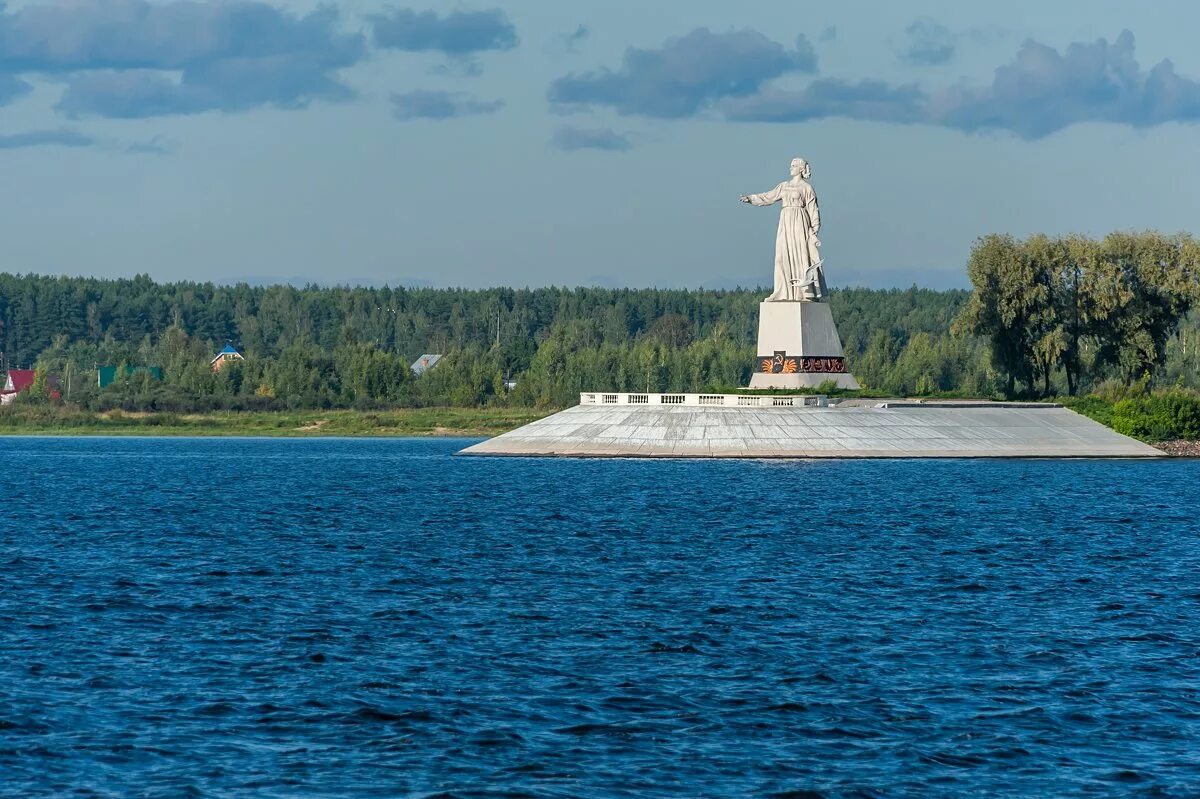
0 0 366 118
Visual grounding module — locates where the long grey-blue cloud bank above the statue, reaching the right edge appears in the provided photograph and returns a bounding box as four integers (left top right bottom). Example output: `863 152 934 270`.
547 29 1200 139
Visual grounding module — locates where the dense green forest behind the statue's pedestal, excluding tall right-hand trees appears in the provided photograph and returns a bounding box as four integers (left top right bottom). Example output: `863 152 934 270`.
0 275 985 410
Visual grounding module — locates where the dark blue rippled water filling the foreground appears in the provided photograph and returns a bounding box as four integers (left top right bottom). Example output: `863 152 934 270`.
0 439 1200 797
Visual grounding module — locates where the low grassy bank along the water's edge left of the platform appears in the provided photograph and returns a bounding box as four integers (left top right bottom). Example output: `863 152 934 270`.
0 405 552 437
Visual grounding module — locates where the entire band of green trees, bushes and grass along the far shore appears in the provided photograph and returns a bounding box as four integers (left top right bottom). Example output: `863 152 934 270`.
0 233 1200 440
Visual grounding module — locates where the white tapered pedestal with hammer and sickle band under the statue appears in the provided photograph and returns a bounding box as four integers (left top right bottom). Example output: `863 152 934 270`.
750 302 860 389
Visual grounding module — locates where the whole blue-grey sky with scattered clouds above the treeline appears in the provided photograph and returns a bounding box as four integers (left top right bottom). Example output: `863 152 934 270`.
0 0 1200 288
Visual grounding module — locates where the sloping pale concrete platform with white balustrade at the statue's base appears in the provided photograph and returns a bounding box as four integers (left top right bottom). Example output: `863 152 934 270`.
461 395 1165 458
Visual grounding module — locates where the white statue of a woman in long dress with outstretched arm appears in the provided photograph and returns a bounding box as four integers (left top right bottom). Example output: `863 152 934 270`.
740 158 826 302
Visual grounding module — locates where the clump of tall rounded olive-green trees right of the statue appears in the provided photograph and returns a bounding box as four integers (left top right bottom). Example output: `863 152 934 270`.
955 232 1200 396
